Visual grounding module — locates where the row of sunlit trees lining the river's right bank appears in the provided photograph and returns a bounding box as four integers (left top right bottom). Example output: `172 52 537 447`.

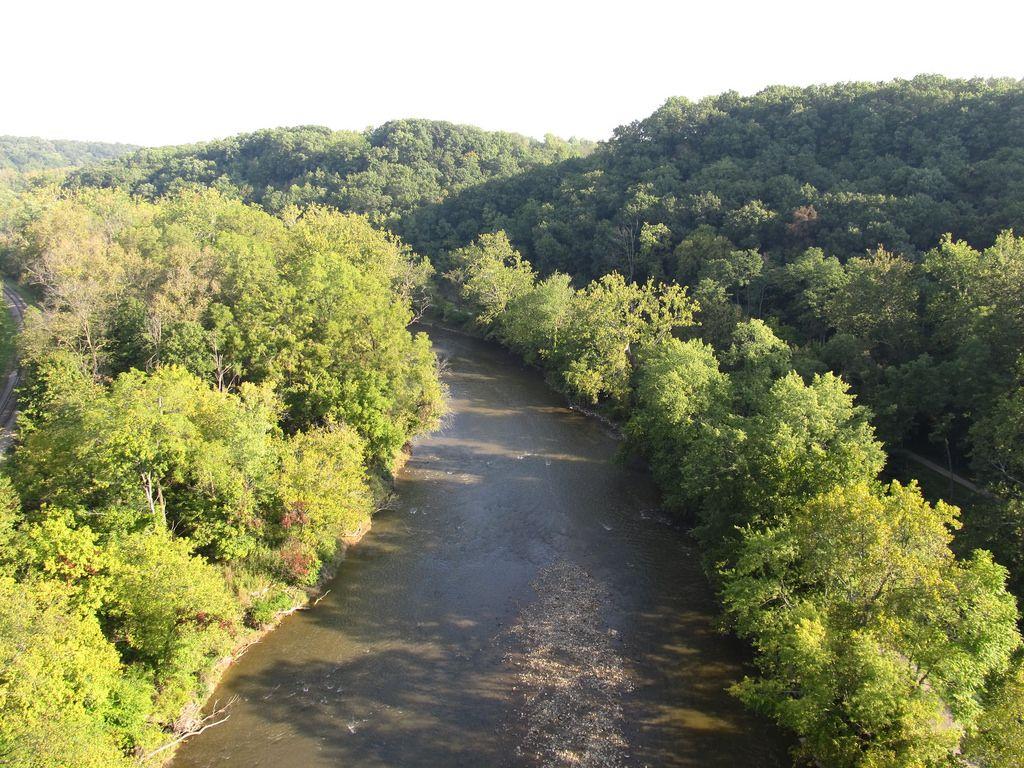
444 231 1022 767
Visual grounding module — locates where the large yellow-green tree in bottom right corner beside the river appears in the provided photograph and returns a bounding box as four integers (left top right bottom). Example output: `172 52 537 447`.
723 482 1020 766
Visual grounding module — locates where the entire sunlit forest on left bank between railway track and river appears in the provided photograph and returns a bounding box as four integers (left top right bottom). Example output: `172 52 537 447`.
0 187 443 768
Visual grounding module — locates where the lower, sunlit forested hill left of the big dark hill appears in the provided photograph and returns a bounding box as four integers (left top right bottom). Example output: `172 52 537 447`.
69 120 594 221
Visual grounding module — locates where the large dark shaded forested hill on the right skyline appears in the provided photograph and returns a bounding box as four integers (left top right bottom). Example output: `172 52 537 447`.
399 75 1024 279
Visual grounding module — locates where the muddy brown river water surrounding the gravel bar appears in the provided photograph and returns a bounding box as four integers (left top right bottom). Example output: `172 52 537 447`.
173 331 787 768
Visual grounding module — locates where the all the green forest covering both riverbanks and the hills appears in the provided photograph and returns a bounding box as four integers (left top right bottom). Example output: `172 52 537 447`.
6 70 1024 768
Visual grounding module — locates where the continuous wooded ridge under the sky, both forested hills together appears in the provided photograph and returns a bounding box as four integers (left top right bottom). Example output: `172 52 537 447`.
68 75 1024 280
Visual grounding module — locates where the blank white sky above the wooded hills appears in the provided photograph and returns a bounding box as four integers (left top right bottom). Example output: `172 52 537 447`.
0 0 1024 144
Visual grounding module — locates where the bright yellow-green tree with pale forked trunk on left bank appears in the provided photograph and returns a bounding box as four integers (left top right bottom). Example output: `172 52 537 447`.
14 367 278 559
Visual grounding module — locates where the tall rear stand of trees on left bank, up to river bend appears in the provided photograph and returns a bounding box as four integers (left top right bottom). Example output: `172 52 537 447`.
16 190 441 469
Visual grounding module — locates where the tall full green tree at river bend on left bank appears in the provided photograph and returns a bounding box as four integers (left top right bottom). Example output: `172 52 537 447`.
272 210 441 469
